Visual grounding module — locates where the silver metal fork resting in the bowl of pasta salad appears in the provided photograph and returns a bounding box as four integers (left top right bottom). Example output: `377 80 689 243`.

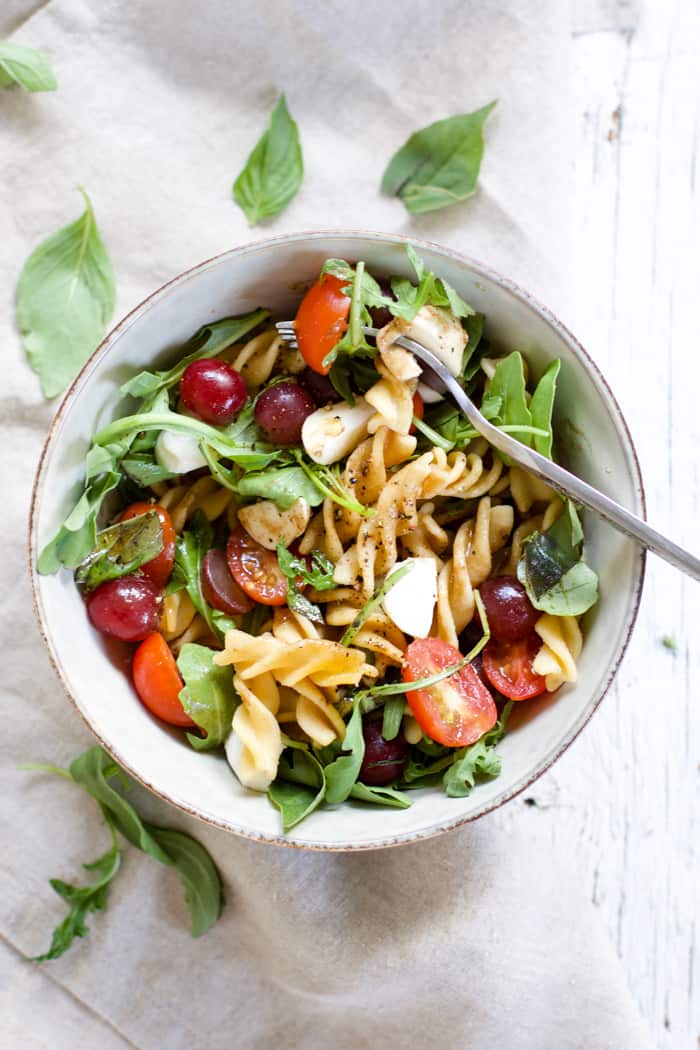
276 321 700 581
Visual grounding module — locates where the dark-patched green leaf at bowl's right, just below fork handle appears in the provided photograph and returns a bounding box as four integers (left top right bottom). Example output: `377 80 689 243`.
517 501 598 616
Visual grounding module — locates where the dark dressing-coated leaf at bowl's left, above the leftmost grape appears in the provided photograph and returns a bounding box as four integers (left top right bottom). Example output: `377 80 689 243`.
76 510 163 591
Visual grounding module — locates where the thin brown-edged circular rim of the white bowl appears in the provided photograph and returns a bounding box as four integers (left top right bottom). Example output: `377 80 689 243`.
27 228 646 853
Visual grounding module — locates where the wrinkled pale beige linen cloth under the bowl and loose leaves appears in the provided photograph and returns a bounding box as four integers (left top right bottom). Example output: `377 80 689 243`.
0 0 650 1050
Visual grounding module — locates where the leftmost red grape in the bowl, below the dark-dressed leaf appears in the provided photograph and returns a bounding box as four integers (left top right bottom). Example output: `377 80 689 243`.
87 576 161 642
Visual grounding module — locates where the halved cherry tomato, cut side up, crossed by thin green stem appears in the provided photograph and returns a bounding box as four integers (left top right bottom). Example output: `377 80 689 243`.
402 638 499 748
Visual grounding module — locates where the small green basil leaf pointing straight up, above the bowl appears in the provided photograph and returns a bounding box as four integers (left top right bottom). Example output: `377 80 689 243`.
233 95 303 226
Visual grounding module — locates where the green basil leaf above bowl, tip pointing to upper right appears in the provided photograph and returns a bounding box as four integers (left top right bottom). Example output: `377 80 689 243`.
381 102 495 213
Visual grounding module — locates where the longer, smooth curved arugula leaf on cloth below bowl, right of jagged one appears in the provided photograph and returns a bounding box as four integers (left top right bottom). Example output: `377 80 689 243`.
69 747 221 937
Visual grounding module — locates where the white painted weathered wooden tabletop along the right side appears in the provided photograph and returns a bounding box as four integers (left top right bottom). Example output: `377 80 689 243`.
499 0 700 1050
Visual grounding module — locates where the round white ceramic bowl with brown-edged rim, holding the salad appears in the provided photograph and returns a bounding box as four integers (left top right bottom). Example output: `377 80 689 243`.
29 231 644 849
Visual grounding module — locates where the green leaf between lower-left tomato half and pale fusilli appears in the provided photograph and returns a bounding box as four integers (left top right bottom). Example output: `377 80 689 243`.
177 642 239 751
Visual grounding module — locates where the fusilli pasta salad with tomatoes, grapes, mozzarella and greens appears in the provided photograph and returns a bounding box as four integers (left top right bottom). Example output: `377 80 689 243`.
39 247 597 831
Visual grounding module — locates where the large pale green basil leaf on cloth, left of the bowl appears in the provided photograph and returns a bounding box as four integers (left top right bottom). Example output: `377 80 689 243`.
17 189 115 398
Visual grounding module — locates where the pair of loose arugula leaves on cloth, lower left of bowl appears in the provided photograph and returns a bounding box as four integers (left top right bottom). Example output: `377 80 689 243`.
23 747 222 962
